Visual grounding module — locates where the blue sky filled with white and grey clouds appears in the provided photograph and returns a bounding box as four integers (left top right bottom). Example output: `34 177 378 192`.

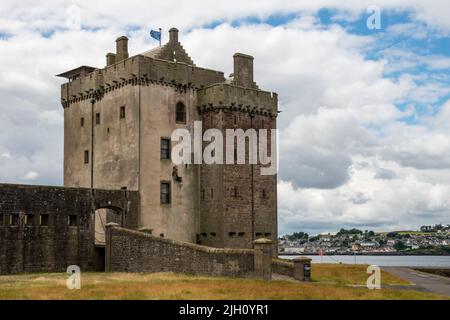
0 0 450 234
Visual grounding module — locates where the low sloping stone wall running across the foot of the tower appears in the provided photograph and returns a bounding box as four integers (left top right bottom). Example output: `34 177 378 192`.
106 226 254 276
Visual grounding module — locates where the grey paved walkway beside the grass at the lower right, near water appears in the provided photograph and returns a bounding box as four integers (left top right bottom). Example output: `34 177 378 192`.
381 267 450 296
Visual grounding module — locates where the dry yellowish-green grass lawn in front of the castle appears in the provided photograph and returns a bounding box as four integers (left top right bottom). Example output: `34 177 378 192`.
0 264 448 300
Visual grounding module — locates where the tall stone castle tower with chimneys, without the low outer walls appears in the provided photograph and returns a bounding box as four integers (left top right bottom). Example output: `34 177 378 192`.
59 28 277 250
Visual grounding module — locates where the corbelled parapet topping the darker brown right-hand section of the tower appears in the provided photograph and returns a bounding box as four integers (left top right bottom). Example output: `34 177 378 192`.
197 83 278 117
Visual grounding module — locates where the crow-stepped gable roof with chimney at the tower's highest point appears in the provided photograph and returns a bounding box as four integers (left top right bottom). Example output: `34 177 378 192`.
142 28 195 66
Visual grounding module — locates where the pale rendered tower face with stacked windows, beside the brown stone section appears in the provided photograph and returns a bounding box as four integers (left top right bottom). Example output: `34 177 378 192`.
139 84 199 243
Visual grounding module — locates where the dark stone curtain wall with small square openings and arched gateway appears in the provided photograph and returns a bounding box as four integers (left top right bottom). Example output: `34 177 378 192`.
0 184 138 274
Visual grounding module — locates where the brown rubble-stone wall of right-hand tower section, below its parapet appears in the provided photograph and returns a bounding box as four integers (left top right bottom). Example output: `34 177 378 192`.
200 108 278 255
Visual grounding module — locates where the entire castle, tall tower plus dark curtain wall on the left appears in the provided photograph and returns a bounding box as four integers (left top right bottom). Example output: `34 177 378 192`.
0 28 278 272
